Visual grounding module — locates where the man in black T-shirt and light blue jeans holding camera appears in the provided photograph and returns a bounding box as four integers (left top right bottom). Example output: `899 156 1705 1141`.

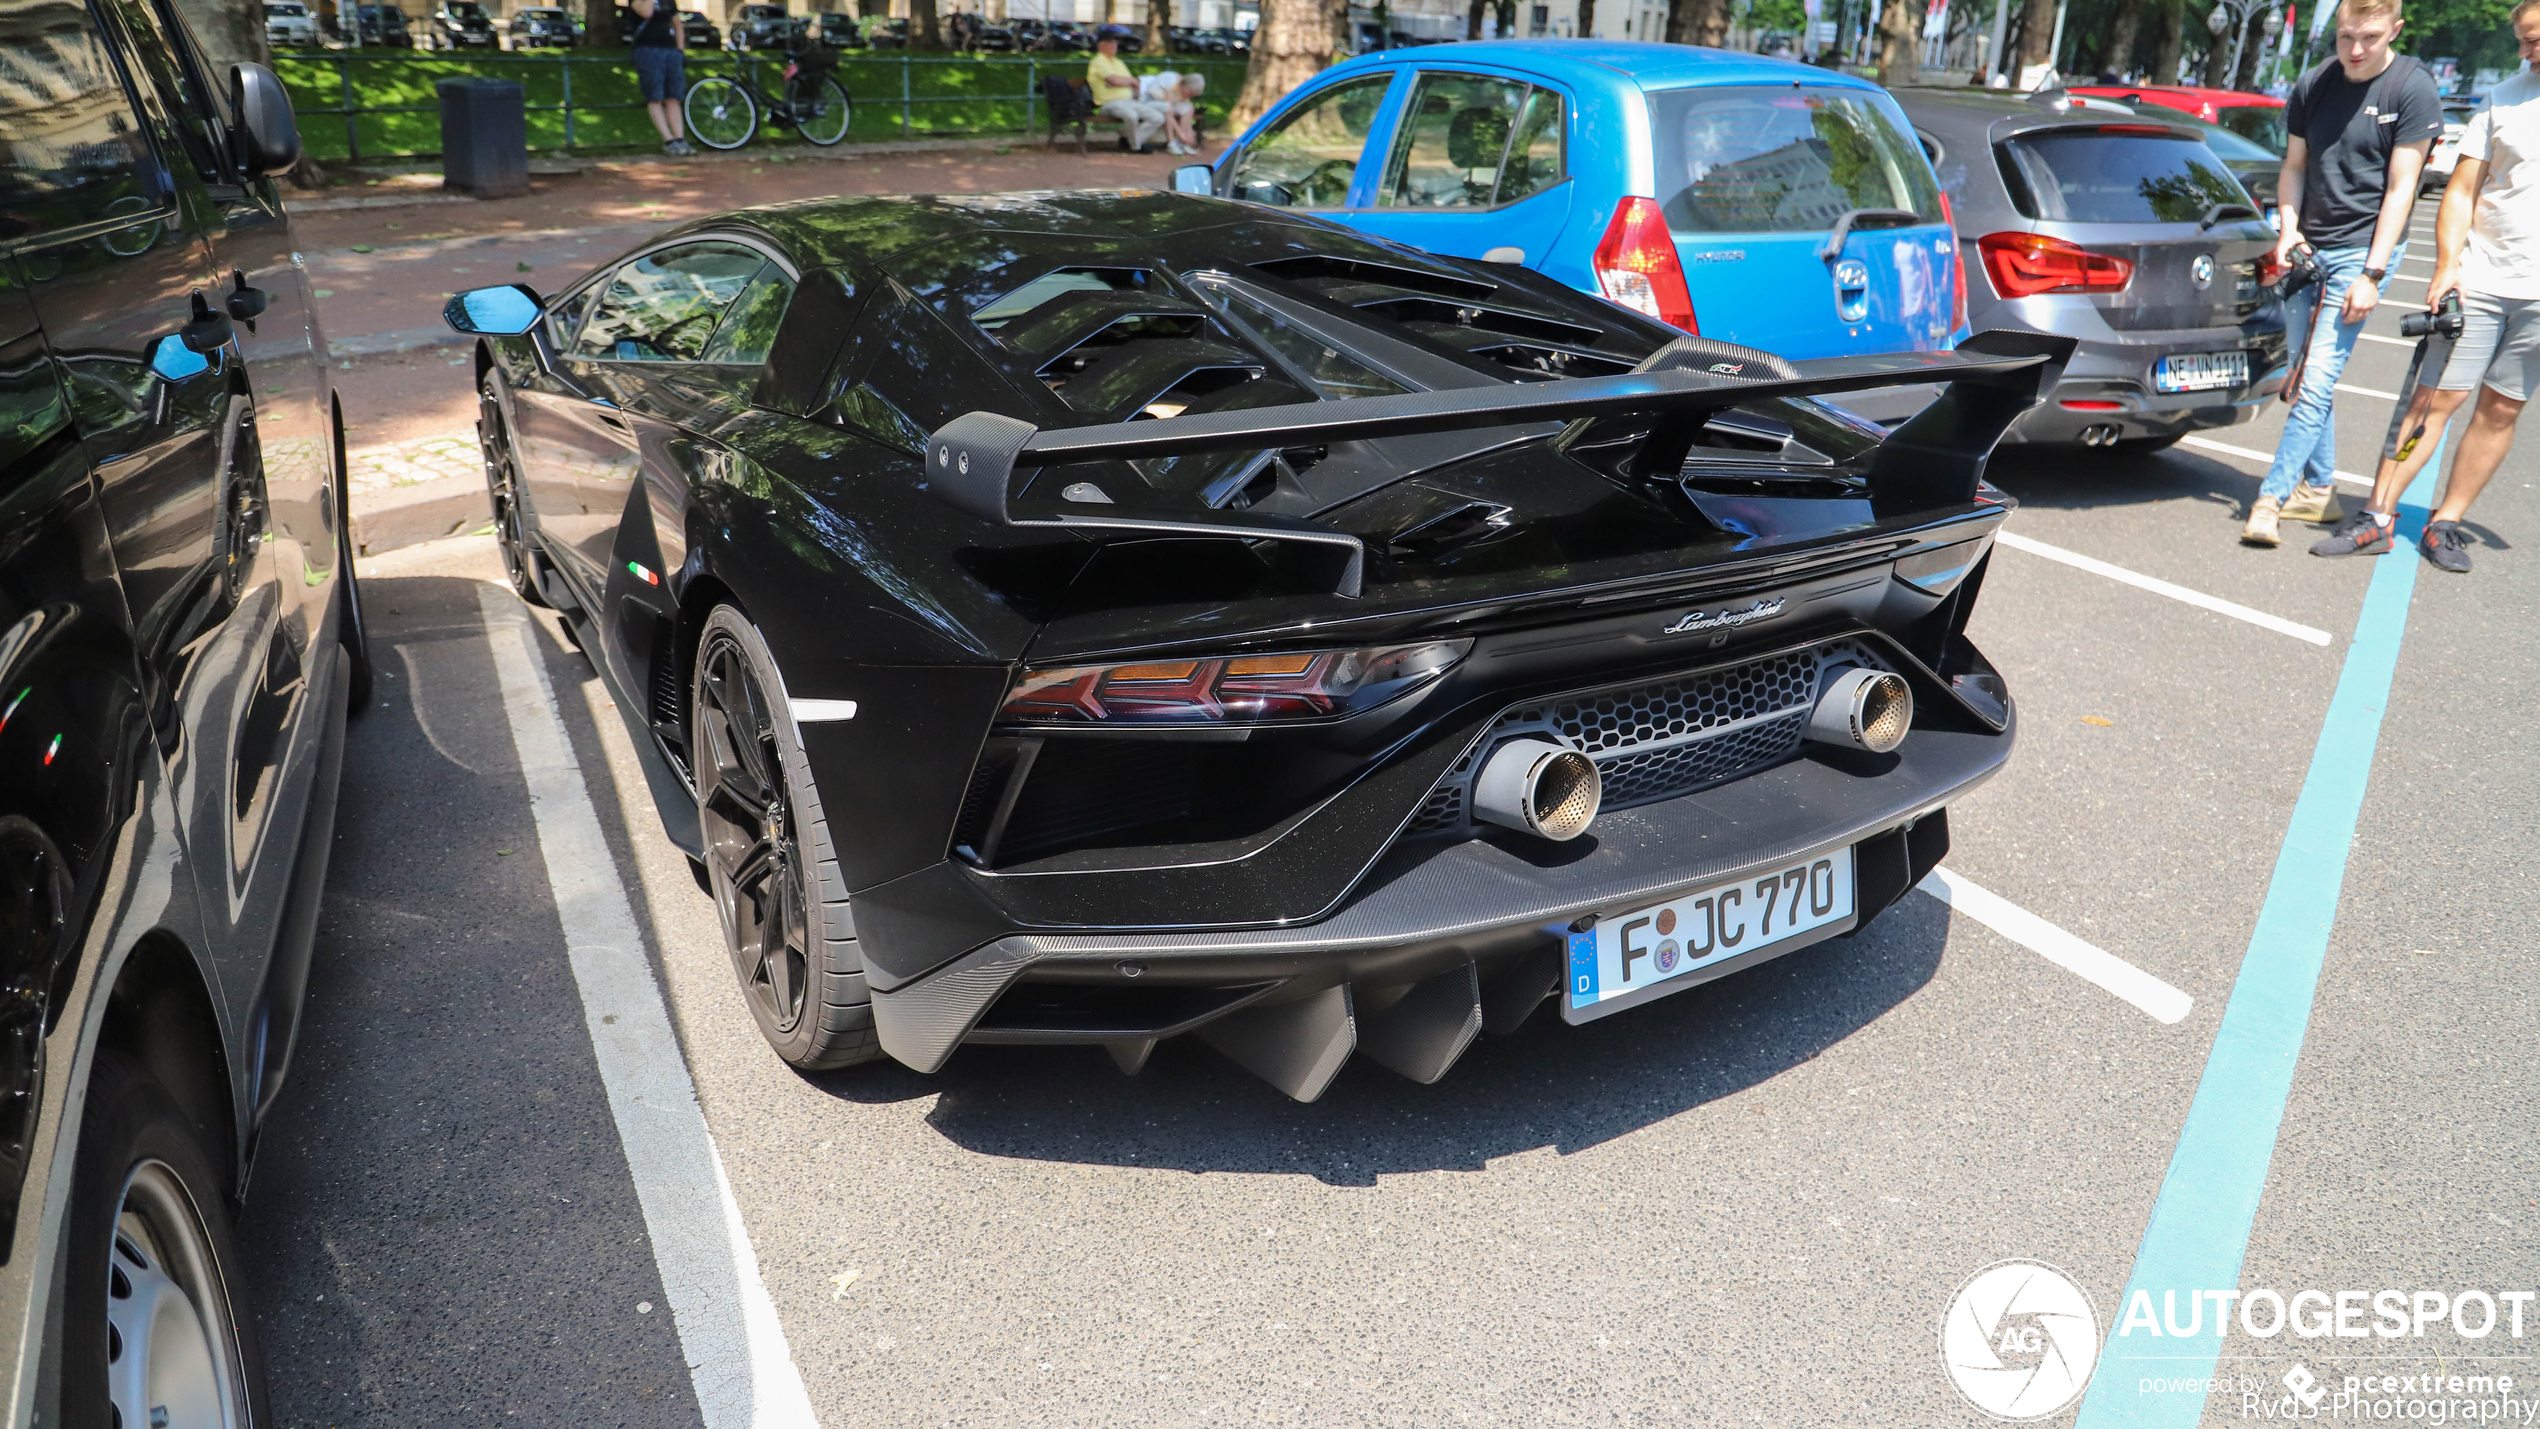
2240 0 2443 546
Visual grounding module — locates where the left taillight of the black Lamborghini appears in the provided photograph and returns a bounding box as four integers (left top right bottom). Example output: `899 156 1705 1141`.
998 640 1473 726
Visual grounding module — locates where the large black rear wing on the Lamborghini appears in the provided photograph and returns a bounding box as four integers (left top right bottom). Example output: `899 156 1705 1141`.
927 330 2075 596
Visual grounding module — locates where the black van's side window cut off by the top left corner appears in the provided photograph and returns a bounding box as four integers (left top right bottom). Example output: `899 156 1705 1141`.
0 0 157 239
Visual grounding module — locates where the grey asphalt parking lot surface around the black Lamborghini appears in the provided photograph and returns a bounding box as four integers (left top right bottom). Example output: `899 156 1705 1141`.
228 206 2540 1429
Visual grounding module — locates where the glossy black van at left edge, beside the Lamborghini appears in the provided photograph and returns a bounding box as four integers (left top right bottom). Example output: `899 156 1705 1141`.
0 0 371 1426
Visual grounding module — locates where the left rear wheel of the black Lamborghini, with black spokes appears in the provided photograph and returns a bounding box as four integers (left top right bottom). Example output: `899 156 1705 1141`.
688 607 881 1071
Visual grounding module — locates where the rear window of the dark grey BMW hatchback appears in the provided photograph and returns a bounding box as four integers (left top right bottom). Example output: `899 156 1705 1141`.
2002 127 2248 223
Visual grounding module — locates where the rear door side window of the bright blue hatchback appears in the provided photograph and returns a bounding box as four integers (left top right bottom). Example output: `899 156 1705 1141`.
1377 74 1562 208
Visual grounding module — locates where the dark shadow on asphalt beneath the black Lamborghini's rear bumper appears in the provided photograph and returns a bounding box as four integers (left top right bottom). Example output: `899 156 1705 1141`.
810 896 1948 1185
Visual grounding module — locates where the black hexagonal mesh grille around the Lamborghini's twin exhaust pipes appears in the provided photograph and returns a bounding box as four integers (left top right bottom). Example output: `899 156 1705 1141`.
1407 640 1887 835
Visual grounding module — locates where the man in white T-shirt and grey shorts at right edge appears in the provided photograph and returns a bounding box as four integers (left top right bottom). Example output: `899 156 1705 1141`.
2311 0 2540 574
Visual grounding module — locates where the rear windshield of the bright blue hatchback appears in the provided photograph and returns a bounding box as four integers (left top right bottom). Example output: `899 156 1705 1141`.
1648 84 1941 234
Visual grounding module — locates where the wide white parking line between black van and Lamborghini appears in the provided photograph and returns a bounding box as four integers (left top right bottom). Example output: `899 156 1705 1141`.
478 584 818 1429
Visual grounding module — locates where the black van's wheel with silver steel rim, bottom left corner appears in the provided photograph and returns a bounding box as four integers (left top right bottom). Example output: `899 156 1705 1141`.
61 1048 267 1429
